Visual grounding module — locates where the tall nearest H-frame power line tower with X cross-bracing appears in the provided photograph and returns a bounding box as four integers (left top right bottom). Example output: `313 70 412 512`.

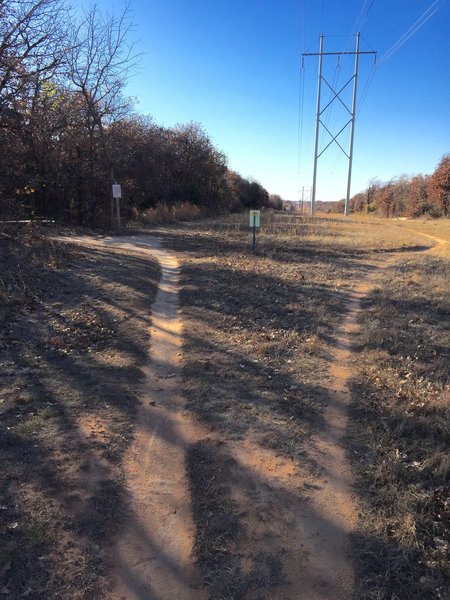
302 32 376 215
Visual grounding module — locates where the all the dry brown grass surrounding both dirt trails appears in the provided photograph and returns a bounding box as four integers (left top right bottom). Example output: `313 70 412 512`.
0 214 450 600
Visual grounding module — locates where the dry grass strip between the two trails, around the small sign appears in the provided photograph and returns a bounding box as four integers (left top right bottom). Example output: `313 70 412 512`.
154 216 436 599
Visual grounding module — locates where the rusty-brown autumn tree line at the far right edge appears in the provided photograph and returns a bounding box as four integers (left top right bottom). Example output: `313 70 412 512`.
337 154 450 218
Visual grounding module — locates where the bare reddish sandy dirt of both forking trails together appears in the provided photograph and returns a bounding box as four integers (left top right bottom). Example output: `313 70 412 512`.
59 231 445 600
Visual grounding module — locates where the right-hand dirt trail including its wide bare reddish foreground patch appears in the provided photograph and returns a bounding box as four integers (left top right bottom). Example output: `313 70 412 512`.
215 256 408 600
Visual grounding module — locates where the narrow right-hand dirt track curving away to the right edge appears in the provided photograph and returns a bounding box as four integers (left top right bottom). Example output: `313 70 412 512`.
274 232 448 600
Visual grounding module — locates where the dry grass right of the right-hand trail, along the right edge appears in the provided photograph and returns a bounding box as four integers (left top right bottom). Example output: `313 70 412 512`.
350 256 450 600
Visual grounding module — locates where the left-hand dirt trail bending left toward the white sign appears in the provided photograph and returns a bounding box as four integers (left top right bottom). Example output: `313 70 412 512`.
61 236 206 600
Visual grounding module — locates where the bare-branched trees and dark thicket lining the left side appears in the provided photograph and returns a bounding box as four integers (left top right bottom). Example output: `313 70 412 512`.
0 0 271 226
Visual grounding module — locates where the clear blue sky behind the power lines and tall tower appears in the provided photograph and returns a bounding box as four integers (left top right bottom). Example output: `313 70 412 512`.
84 0 450 200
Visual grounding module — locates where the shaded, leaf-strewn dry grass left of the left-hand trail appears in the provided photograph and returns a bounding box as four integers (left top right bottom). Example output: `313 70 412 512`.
0 229 159 600
